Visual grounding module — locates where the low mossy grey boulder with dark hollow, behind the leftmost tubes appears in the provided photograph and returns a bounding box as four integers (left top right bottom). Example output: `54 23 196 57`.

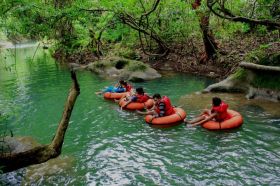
86 57 161 81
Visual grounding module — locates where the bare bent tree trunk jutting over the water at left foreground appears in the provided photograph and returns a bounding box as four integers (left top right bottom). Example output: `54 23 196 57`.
0 71 80 172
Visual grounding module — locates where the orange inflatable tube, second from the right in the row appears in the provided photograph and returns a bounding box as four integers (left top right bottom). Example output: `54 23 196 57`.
145 108 187 125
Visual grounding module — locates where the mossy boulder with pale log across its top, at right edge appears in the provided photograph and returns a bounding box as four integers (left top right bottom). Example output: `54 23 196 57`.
203 62 280 102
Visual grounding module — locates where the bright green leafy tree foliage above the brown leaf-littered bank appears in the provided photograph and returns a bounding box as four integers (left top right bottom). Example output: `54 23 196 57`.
0 0 280 59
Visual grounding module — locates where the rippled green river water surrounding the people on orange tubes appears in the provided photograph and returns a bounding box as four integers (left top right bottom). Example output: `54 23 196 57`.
0 44 280 185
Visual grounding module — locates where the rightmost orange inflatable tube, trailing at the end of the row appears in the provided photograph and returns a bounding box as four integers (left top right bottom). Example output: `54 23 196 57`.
202 110 243 130
